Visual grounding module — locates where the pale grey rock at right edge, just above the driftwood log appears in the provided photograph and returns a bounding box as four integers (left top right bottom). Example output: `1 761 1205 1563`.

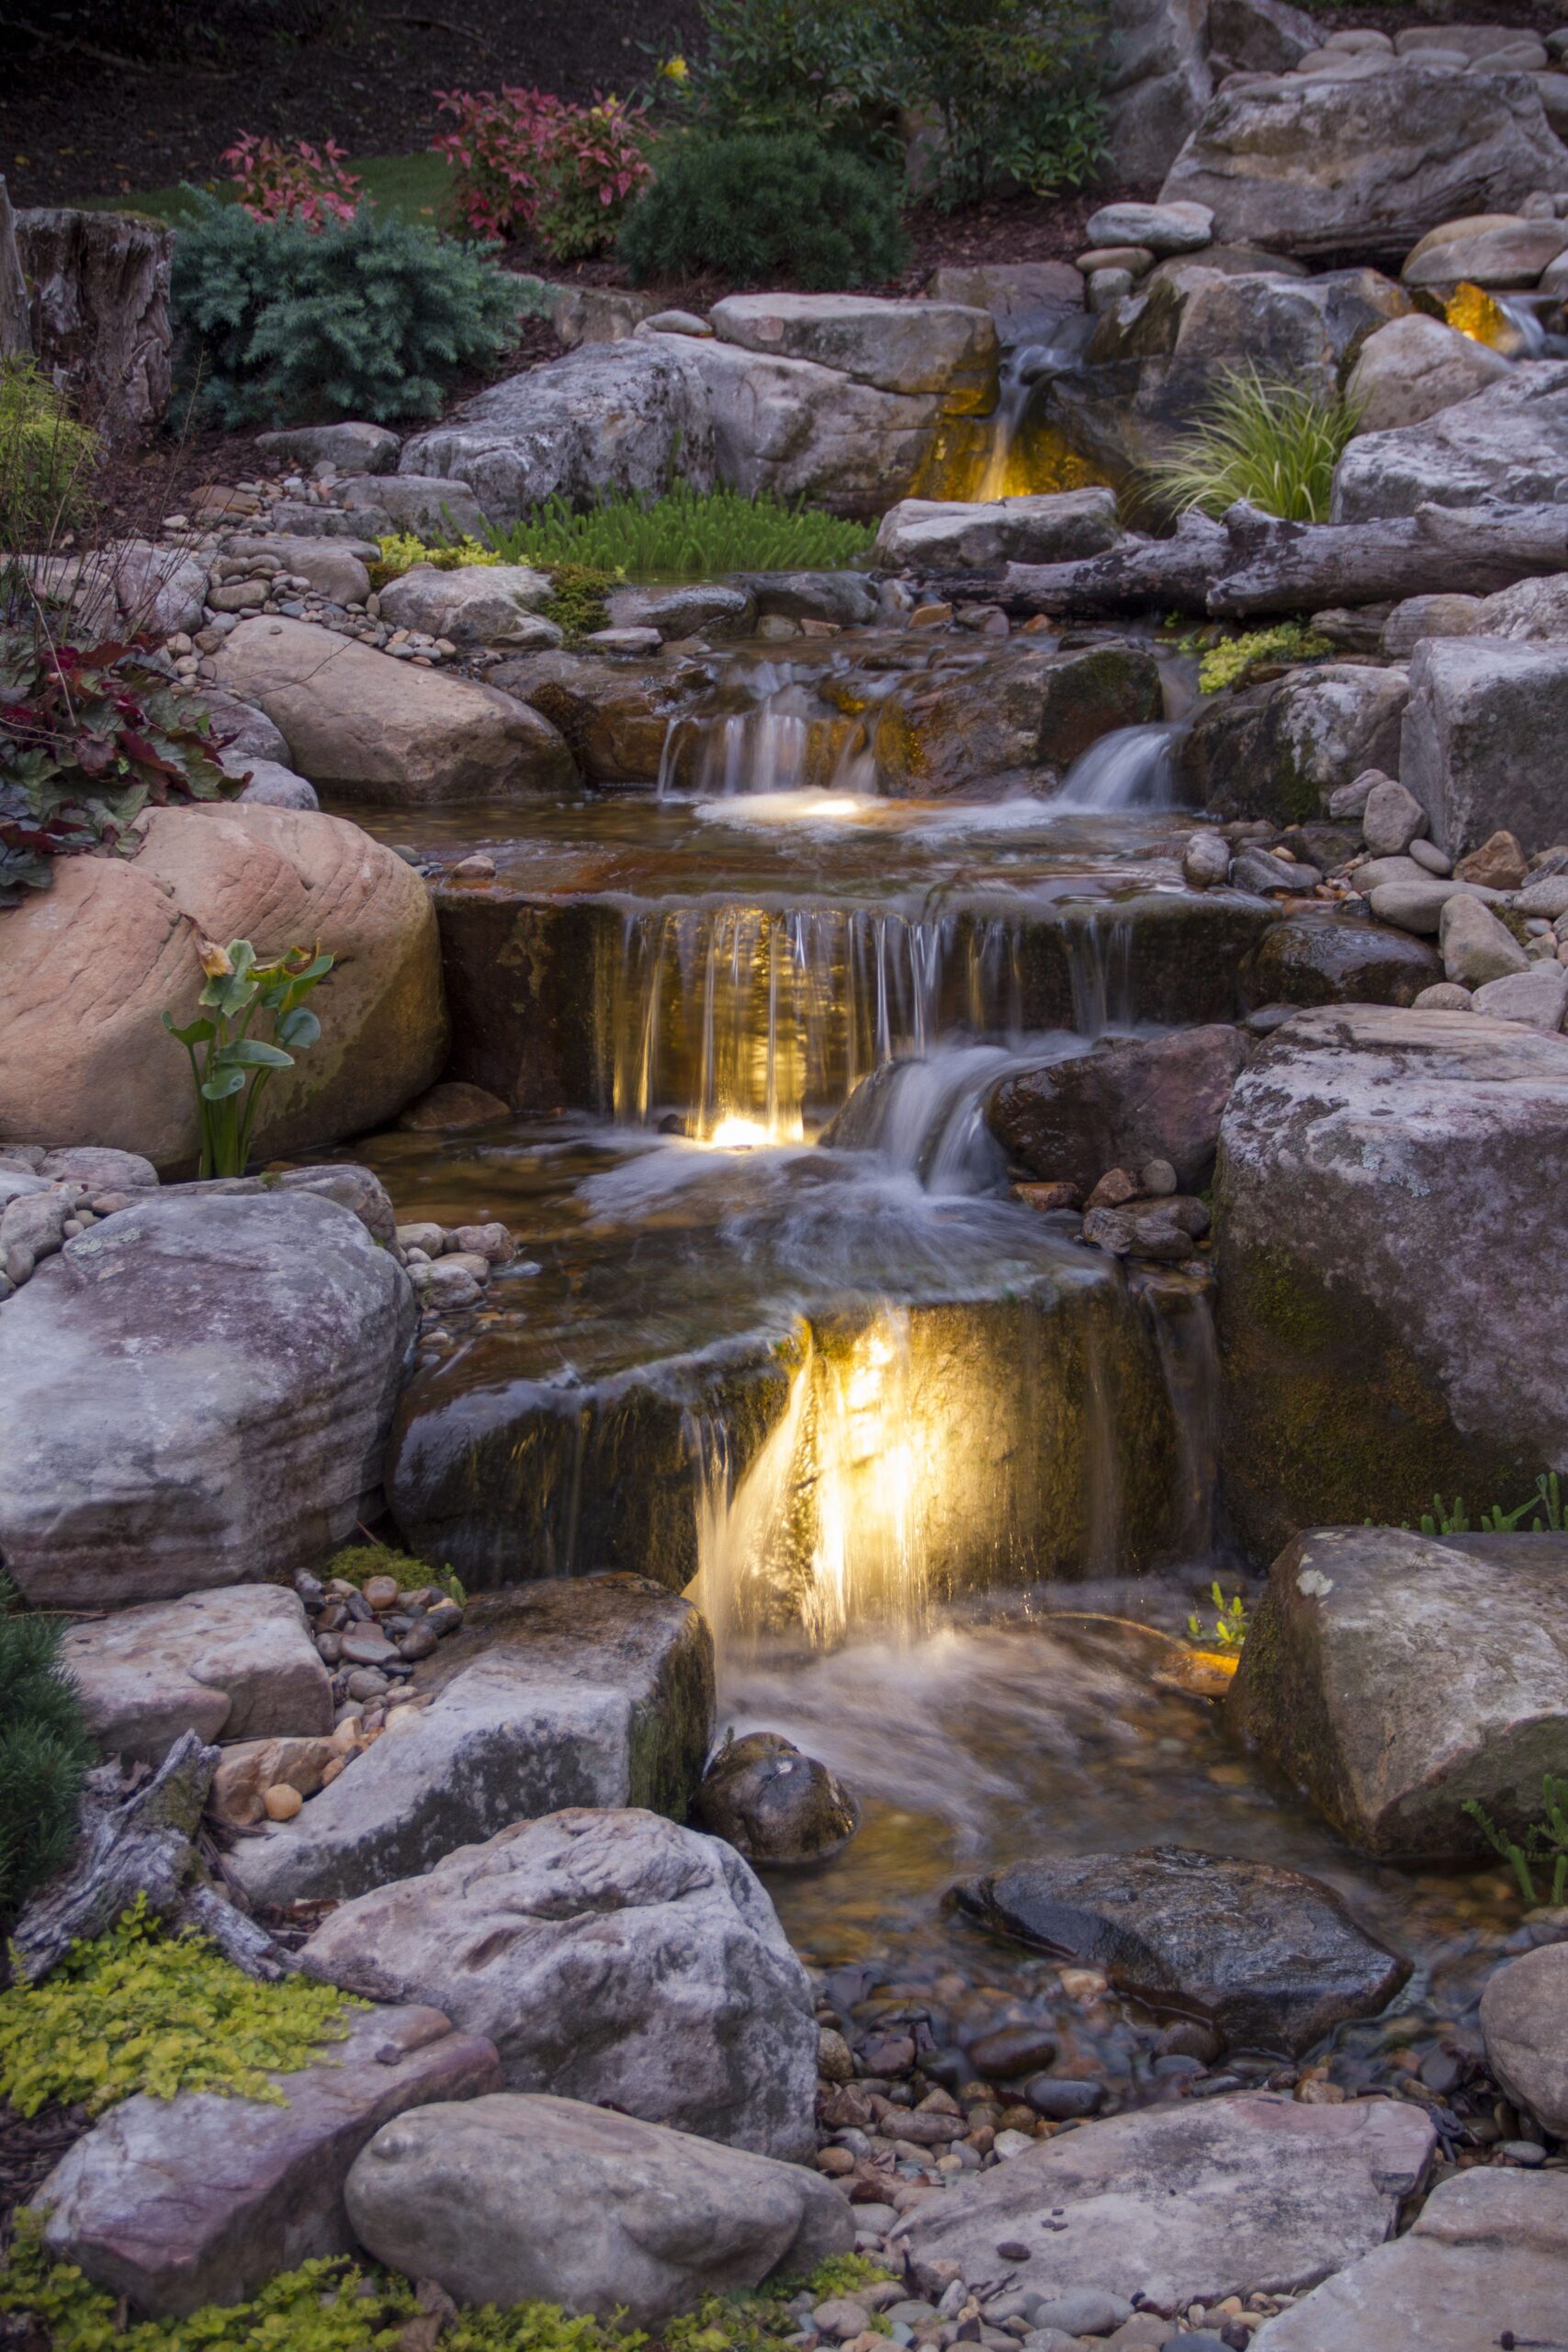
1331 360 1568 522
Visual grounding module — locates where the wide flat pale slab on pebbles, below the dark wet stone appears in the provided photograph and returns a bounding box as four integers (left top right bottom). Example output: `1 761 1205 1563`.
898 2091 1437 2304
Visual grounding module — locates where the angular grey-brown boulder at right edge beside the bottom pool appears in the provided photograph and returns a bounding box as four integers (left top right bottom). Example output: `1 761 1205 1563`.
1224 1526 1568 1858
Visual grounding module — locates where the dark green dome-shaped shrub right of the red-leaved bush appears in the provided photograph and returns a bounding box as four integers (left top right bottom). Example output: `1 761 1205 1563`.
621 131 908 289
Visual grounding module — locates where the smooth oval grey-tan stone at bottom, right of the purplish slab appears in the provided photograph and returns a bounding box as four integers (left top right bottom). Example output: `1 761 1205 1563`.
345 2093 856 2331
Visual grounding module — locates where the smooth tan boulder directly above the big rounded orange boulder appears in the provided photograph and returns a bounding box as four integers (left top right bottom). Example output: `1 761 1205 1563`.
214 618 576 805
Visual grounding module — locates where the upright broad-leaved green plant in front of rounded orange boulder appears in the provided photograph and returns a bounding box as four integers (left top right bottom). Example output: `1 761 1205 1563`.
163 938 333 1176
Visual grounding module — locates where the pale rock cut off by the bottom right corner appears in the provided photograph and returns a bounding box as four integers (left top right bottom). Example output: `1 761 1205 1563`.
1253 2168 1568 2352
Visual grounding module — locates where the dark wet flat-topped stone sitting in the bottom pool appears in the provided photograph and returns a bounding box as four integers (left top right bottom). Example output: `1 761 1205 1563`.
957 1847 1411 2055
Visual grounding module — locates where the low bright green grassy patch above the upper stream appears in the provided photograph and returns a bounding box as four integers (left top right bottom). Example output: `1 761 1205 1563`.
489 482 877 588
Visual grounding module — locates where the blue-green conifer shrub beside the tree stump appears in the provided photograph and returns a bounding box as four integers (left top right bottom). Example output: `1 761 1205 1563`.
172 190 526 430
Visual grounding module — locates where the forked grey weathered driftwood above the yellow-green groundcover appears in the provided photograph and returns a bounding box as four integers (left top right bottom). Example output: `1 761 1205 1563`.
12 1731 285 1985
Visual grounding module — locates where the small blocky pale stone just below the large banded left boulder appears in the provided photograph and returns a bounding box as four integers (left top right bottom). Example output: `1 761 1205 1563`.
63 1585 332 1764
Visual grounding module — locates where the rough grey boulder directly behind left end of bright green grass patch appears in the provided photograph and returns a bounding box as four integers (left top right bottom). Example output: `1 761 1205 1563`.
400 336 715 522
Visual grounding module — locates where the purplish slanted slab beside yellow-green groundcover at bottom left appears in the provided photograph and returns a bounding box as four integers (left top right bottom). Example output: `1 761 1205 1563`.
33 2008 501 2317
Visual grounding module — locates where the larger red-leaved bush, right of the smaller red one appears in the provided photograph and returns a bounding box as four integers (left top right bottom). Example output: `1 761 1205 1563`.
434 89 651 261
